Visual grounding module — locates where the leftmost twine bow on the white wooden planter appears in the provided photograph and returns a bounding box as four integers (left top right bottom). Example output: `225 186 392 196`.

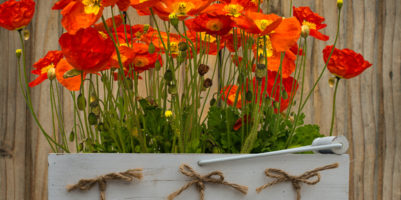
67 169 143 200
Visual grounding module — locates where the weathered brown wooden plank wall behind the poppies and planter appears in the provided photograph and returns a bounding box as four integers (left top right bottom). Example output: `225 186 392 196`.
0 0 401 200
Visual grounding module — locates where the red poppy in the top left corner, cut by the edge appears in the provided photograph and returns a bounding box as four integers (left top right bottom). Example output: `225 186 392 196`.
0 0 35 31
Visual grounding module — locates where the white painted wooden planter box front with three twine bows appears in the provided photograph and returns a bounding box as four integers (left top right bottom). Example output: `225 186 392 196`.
48 154 349 200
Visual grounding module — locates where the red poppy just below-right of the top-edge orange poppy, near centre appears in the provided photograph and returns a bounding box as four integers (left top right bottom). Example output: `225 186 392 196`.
185 13 234 35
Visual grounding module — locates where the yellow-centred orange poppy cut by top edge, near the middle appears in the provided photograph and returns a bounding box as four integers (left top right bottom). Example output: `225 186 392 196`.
153 0 214 21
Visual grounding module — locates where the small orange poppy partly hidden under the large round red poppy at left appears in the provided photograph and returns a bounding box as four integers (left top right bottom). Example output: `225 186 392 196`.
56 58 86 91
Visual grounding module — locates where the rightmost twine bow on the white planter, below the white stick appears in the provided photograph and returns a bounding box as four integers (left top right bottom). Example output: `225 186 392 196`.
256 163 338 200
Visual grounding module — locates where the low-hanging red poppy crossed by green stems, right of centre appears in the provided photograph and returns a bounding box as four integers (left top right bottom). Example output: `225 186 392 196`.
253 71 298 113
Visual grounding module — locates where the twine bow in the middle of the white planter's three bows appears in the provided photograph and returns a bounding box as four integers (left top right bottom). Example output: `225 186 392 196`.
168 164 248 200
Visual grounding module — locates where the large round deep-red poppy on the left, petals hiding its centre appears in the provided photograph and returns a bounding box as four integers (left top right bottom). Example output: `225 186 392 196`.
59 28 114 73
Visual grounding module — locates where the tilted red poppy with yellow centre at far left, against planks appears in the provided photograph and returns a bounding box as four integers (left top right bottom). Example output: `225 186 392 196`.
29 51 63 87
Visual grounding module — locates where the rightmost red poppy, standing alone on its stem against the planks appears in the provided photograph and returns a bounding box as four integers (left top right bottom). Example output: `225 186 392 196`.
323 46 372 79
